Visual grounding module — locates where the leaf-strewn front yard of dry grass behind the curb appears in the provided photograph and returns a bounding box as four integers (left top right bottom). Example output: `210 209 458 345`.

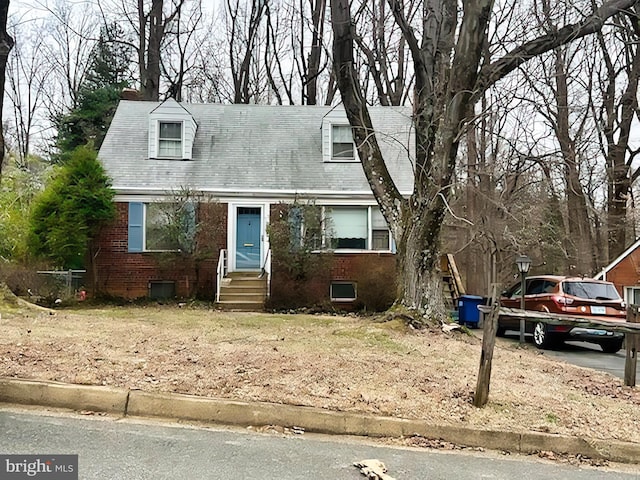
0 296 640 443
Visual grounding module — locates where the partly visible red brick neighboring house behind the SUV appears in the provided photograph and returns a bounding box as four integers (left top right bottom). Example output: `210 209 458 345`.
595 239 640 305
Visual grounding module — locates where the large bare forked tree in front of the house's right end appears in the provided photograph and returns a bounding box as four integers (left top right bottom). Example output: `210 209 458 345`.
331 0 635 318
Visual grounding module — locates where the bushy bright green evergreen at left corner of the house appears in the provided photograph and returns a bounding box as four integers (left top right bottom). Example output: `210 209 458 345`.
28 146 115 268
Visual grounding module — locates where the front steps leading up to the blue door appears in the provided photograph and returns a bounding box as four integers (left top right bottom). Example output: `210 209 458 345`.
218 271 267 312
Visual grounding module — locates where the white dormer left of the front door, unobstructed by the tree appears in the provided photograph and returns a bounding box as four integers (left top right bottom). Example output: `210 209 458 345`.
149 98 198 160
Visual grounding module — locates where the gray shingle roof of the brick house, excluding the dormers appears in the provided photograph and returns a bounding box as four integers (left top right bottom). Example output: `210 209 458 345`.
99 100 413 196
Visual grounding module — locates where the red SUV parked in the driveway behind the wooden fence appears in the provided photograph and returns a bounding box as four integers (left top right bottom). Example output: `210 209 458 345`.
497 275 627 353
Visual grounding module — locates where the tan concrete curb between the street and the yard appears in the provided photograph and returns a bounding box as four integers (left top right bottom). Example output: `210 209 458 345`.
0 378 640 463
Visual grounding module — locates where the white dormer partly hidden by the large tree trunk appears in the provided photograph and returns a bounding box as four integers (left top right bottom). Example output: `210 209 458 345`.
322 107 360 162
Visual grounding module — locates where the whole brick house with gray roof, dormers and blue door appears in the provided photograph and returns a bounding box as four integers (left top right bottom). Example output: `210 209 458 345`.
92 99 413 308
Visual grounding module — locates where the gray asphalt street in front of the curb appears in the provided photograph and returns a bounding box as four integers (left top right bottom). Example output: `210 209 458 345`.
0 407 640 480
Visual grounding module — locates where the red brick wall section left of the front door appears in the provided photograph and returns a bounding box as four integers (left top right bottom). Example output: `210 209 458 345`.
87 203 227 299
